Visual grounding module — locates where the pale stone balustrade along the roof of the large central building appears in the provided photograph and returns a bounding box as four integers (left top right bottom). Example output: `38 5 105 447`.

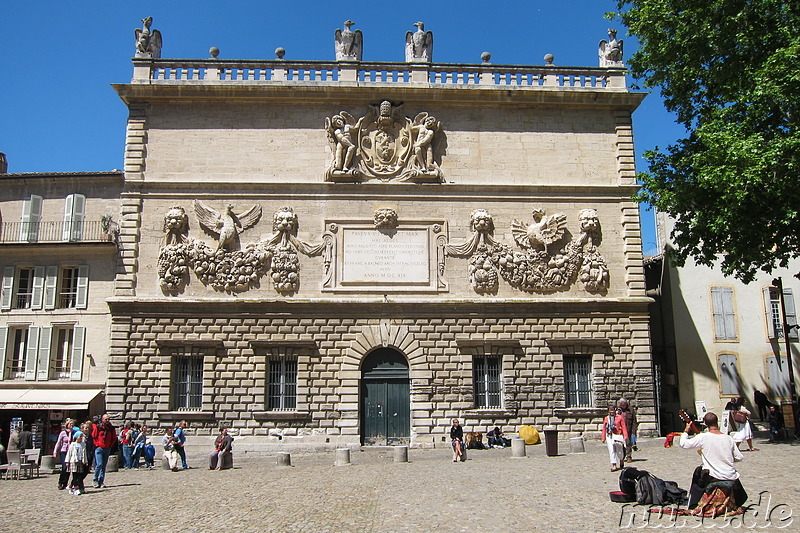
133 59 627 91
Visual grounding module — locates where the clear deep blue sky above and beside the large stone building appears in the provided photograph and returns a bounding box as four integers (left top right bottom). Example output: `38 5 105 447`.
0 0 682 252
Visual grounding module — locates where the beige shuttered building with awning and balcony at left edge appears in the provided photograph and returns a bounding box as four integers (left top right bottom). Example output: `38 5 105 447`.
0 171 123 444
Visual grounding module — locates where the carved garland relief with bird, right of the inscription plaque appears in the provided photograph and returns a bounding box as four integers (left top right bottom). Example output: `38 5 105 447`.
445 209 609 293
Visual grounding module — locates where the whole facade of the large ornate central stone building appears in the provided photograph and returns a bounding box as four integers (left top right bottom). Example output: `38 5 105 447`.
106 21 655 446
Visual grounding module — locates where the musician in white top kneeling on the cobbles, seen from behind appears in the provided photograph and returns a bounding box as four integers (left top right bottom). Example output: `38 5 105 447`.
681 412 747 514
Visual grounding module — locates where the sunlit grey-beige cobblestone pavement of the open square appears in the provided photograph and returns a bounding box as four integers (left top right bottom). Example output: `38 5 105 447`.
0 432 800 533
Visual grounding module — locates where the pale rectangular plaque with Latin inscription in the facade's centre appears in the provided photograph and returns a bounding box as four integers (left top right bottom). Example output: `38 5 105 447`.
341 228 431 285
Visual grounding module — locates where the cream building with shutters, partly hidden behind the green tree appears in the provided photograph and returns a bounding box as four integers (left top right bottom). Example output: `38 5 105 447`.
647 213 800 427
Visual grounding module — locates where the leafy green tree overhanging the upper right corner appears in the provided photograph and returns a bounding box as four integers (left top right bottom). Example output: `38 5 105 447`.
609 0 800 282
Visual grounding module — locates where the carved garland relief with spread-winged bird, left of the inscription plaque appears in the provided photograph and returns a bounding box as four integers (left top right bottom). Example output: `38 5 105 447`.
158 205 330 294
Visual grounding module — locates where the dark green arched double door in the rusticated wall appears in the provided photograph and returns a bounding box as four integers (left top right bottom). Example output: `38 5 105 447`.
361 348 411 445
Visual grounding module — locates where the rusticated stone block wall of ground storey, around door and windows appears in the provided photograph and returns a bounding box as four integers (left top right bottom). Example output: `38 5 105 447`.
107 302 655 446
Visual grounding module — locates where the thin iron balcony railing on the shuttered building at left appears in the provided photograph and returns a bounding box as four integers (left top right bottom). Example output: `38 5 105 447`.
0 220 117 243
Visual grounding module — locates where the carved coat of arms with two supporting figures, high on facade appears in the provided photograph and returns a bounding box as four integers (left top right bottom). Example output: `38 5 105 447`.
325 100 443 183
